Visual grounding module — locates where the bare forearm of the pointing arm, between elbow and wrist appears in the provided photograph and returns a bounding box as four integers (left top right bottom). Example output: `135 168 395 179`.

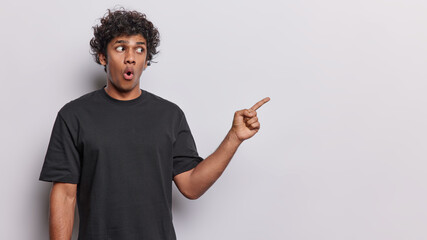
190 130 242 198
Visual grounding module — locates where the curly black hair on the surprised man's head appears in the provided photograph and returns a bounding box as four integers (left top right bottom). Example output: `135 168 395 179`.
90 8 160 71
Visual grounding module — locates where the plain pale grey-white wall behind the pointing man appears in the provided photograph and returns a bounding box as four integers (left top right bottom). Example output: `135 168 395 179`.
0 0 427 240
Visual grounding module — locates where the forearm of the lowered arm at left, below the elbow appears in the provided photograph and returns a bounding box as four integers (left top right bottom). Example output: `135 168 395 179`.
49 189 76 240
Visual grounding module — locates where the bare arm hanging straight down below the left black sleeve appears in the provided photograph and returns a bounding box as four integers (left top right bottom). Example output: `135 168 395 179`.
49 182 77 240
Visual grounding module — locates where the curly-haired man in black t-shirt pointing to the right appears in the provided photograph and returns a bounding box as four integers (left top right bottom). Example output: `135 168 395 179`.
39 7 269 240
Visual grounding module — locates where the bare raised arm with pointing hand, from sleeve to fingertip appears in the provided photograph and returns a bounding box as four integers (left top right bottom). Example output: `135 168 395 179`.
174 98 270 199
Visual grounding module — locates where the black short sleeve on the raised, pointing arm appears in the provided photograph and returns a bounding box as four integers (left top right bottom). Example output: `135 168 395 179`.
173 112 203 177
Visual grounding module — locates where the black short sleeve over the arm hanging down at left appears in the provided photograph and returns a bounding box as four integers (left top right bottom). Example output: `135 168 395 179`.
39 112 80 184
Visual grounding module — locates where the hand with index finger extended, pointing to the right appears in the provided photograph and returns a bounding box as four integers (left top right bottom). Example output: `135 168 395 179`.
230 97 270 142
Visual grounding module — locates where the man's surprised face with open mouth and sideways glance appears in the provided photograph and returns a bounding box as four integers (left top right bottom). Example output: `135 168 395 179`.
99 34 147 92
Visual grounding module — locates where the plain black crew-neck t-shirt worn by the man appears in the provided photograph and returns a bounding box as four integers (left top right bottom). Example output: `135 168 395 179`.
39 86 203 240
